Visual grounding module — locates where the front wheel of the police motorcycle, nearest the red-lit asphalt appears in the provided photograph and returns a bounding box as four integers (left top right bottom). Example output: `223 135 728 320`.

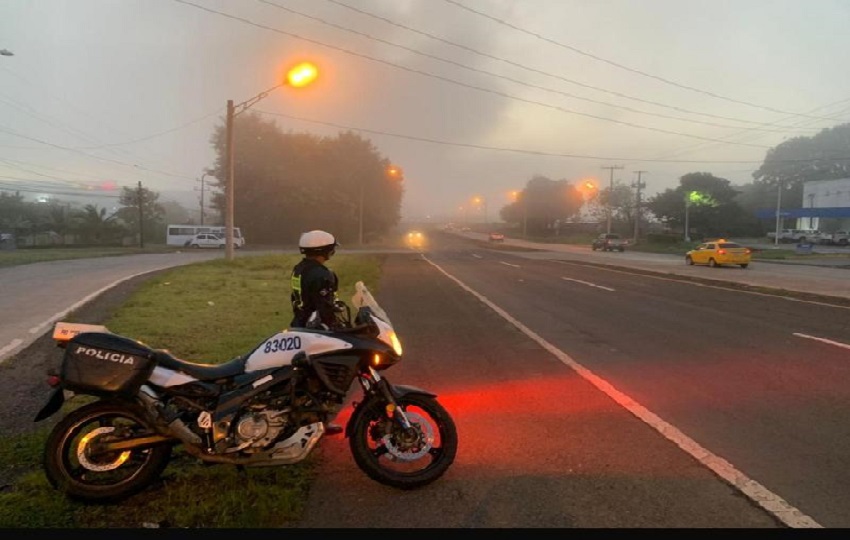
349 394 457 489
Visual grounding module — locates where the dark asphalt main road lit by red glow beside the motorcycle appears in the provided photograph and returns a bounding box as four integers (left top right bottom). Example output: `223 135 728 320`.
0 237 850 528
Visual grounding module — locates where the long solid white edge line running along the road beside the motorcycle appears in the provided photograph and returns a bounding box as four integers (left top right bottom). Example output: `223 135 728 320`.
423 256 823 528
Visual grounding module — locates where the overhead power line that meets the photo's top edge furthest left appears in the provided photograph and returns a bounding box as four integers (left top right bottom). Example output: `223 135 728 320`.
174 0 770 149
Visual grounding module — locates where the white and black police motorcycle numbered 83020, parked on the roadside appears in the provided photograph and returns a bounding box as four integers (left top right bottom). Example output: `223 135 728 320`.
35 282 458 503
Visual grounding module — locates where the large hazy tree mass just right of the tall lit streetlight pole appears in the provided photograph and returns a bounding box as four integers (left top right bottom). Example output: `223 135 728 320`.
211 112 404 244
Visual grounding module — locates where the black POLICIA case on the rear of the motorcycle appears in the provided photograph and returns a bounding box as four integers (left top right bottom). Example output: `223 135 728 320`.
60 332 156 396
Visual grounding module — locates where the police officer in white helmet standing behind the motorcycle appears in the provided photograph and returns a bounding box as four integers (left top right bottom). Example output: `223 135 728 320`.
290 230 340 329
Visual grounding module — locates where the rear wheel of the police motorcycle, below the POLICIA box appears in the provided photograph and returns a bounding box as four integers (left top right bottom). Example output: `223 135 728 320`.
43 401 171 503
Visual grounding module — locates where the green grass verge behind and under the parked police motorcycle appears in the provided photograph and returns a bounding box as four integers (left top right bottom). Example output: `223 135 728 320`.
0 254 383 528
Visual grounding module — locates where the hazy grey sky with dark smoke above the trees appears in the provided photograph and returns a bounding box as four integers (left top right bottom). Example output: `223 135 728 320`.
0 0 850 225
